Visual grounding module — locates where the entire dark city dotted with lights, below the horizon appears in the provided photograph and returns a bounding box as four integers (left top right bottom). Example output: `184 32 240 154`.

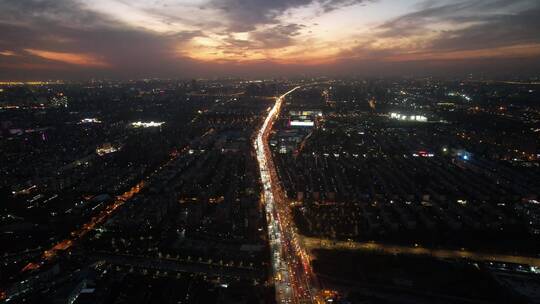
0 77 540 304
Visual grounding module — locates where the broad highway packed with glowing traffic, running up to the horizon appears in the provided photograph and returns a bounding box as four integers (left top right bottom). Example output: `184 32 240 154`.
254 87 316 303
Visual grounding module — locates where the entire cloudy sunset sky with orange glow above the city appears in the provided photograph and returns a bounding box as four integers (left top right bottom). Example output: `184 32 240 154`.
0 0 540 80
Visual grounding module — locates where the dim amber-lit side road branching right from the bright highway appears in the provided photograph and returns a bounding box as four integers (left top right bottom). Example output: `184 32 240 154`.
302 237 540 267
